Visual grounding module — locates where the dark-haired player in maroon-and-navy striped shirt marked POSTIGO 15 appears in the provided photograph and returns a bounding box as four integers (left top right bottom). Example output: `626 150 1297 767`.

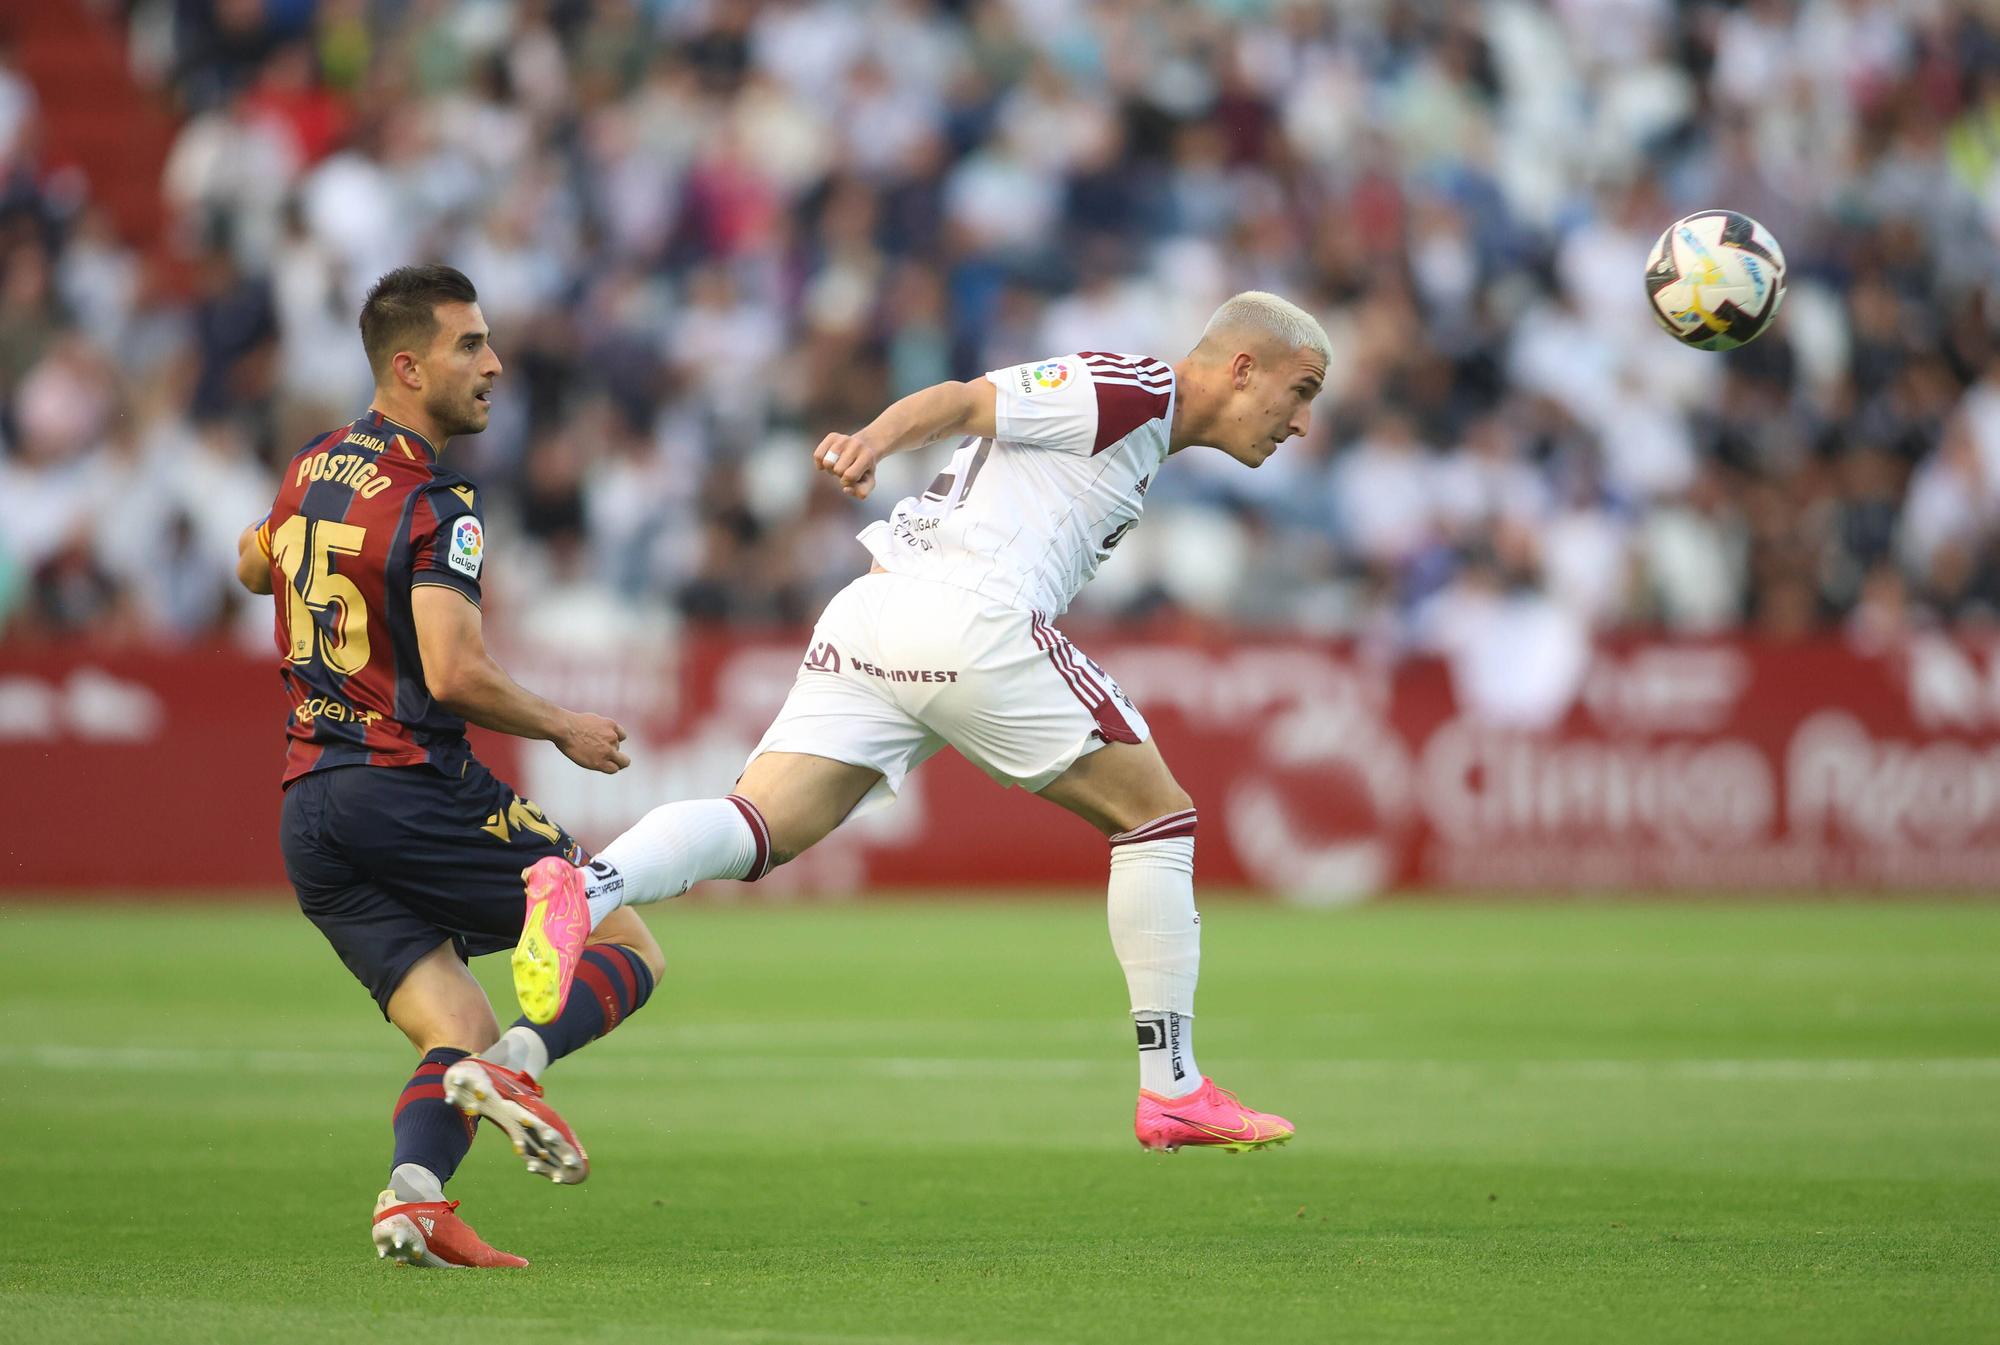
238 266 664 1267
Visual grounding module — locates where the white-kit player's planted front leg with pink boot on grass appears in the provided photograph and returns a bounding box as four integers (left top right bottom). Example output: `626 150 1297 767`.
1040 739 1292 1153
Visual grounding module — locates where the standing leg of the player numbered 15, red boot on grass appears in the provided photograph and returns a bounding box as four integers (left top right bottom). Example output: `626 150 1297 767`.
370 943 528 1267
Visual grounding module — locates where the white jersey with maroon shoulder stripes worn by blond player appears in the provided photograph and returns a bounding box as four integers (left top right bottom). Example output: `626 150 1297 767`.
860 350 1174 616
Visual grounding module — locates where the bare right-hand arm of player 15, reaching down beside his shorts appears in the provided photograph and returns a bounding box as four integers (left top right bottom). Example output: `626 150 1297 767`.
410 584 632 775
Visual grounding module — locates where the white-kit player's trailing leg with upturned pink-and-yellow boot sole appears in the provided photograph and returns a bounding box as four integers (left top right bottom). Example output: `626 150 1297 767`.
514 751 882 1023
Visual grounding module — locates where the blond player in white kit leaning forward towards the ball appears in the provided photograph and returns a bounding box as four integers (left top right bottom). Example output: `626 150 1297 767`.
500 290 1330 1151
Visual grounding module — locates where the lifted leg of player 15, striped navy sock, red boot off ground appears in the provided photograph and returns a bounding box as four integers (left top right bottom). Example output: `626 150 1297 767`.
458 908 666 1185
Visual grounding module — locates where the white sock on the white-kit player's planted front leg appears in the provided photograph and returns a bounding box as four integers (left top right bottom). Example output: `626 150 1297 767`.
1106 809 1202 1097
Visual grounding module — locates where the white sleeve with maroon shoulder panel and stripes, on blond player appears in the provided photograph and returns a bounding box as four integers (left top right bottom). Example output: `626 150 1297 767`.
986 350 1174 458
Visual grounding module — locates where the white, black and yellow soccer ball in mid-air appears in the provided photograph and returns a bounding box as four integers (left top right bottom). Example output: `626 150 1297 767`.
1646 210 1784 350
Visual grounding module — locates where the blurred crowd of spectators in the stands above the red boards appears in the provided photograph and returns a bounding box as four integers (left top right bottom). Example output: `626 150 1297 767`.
0 0 2000 672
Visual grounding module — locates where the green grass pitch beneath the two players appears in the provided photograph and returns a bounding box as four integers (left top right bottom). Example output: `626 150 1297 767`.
0 897 2000 1345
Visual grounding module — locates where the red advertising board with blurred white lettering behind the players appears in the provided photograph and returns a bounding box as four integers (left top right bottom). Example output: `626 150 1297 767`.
11 634 2000 903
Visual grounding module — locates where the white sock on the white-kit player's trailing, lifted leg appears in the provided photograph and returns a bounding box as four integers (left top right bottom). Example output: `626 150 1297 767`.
584 795 770 929
